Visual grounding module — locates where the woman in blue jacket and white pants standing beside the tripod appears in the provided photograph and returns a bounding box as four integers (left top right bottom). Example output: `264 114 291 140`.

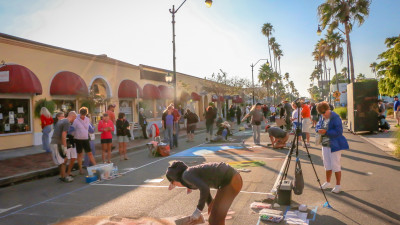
315 102 349 194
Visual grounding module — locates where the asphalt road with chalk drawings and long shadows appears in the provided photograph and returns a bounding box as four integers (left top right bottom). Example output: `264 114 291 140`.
0 126 400 225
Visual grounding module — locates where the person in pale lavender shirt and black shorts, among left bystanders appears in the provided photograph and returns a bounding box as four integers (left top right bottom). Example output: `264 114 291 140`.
72 107 96 175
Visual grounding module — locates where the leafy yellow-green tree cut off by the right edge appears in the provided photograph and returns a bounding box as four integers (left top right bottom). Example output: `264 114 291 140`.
376 35 400 96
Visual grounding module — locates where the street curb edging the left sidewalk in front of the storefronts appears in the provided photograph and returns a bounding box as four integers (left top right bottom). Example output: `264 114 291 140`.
0 129 206 188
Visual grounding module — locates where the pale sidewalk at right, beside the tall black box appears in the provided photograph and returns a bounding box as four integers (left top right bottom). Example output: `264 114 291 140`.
359 116 399 156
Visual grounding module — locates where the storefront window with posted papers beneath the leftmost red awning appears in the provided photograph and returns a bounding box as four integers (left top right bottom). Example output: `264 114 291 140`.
0 98 31 134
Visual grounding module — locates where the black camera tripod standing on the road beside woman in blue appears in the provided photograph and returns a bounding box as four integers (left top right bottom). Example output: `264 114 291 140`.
274 100 332 208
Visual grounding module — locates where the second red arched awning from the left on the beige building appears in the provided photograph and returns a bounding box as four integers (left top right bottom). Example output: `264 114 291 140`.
50 71 88 96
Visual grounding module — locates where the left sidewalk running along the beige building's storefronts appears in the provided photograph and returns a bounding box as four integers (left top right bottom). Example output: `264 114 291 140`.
0 121 205 187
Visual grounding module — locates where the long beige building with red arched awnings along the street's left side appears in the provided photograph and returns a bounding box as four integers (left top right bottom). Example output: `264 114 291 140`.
0 33 216 150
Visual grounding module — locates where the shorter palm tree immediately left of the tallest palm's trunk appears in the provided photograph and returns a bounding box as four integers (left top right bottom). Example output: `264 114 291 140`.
326 31 344 90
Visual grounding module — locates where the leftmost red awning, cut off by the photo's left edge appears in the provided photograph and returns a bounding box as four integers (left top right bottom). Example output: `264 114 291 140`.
0 64 42 95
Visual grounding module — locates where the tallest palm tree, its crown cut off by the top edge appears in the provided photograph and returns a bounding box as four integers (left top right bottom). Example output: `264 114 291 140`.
318 0 371 83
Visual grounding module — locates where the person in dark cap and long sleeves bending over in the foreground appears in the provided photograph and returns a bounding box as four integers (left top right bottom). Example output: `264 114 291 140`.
166 161 243 225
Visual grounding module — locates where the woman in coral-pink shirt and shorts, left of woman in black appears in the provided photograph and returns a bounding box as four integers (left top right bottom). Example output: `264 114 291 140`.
97 113 114 163
